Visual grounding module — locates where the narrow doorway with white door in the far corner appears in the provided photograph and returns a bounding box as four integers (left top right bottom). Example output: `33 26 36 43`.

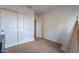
34 17 43 38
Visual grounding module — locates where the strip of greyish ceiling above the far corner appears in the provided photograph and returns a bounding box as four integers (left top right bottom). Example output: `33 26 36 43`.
27 5 60 14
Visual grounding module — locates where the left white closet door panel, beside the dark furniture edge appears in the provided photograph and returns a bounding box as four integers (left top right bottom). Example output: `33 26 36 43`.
1 9 17 48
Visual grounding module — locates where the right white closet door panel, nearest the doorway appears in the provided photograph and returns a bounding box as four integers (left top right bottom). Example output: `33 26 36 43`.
18 13 34 44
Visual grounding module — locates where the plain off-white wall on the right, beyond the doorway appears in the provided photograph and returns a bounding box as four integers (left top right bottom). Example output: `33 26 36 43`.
41 6 79 51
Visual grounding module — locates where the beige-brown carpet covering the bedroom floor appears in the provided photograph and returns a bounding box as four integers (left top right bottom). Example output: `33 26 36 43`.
6 38 63 53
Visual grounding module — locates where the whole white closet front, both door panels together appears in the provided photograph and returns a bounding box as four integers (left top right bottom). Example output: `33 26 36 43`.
0 9 34 48
